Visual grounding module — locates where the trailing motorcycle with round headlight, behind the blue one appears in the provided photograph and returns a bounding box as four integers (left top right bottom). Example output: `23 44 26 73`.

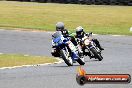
77 32 103 61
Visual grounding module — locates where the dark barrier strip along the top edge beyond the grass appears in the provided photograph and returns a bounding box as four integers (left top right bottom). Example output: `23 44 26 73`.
22 0 132 5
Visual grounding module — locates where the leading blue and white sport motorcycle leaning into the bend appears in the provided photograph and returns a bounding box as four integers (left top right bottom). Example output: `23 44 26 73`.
52 31 85 66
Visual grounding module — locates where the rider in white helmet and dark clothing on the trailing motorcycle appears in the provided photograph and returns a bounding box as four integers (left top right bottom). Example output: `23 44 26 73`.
75 26 104 55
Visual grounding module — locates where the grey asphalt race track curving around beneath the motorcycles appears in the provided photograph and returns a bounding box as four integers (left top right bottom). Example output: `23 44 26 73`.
0 30 132 88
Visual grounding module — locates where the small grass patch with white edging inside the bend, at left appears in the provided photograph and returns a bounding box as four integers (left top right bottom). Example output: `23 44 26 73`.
0 54 58 67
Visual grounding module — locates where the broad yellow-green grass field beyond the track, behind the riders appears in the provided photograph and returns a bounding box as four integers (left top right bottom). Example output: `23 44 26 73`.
0 1 132 35
